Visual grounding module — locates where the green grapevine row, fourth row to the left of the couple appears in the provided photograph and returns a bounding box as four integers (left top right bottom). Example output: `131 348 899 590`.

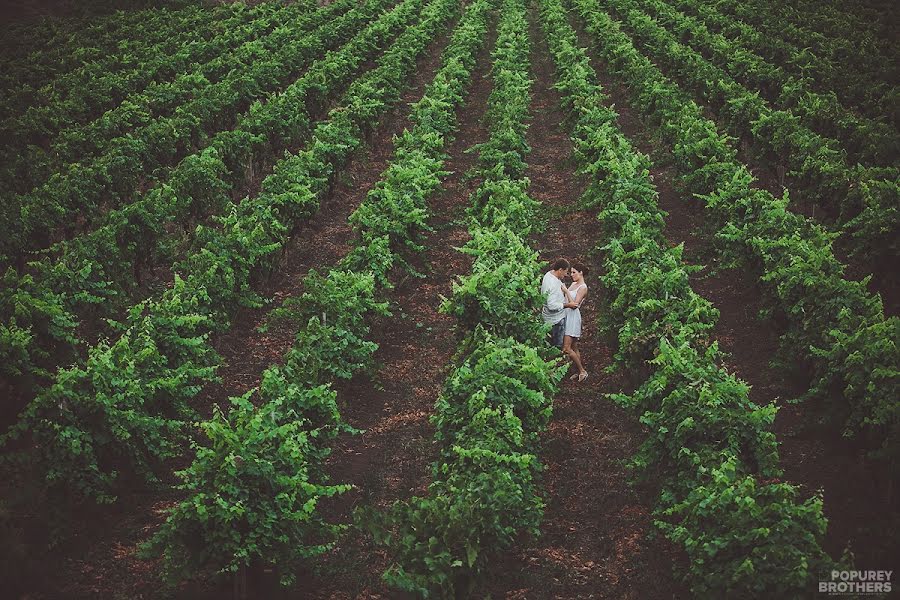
0 0 390 394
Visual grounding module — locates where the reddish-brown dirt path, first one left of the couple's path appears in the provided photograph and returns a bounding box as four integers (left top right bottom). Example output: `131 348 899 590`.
300 16 496 599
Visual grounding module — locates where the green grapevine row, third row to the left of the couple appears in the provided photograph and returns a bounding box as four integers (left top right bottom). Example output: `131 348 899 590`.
4 0 446 502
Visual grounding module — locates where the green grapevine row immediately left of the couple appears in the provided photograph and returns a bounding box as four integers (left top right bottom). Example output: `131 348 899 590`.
373 0 562 598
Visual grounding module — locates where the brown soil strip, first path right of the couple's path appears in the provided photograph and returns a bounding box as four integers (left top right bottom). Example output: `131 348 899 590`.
581 9 900 580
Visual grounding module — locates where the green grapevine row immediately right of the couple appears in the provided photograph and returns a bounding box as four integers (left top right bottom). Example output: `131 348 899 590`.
540 0 832 598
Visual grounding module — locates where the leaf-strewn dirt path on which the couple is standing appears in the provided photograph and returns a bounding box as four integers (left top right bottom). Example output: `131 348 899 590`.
482 10 687 600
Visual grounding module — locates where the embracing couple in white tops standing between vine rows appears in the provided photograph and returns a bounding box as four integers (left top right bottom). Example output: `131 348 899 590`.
541 258 588 381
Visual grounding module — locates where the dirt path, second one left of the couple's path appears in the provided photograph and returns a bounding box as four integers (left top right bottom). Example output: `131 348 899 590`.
24 19 453 599
